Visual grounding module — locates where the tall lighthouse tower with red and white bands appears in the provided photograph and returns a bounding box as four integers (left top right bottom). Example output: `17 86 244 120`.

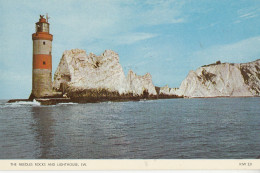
30 15 53 98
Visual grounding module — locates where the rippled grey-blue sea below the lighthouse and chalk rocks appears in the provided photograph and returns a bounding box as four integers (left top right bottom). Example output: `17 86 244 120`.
0 97 260 159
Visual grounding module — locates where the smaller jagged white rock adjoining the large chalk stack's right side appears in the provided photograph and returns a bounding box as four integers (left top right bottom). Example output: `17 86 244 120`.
127 70 157 96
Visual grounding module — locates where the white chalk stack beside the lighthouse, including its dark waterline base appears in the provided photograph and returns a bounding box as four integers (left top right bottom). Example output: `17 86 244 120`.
53 49 161 102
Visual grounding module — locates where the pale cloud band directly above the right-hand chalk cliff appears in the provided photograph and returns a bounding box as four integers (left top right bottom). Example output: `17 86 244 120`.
193 36 260 64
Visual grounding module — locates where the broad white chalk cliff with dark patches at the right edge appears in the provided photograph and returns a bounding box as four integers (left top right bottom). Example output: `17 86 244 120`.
174 59 260 97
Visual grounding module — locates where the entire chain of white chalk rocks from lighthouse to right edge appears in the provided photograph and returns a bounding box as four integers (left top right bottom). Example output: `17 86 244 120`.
53 49 260 102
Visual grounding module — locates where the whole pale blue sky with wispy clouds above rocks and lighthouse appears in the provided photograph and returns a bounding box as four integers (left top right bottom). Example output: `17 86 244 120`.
0 0 260 99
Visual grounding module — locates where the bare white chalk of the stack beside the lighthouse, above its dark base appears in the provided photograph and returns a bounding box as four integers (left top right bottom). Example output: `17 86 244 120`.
53 49 156 96
